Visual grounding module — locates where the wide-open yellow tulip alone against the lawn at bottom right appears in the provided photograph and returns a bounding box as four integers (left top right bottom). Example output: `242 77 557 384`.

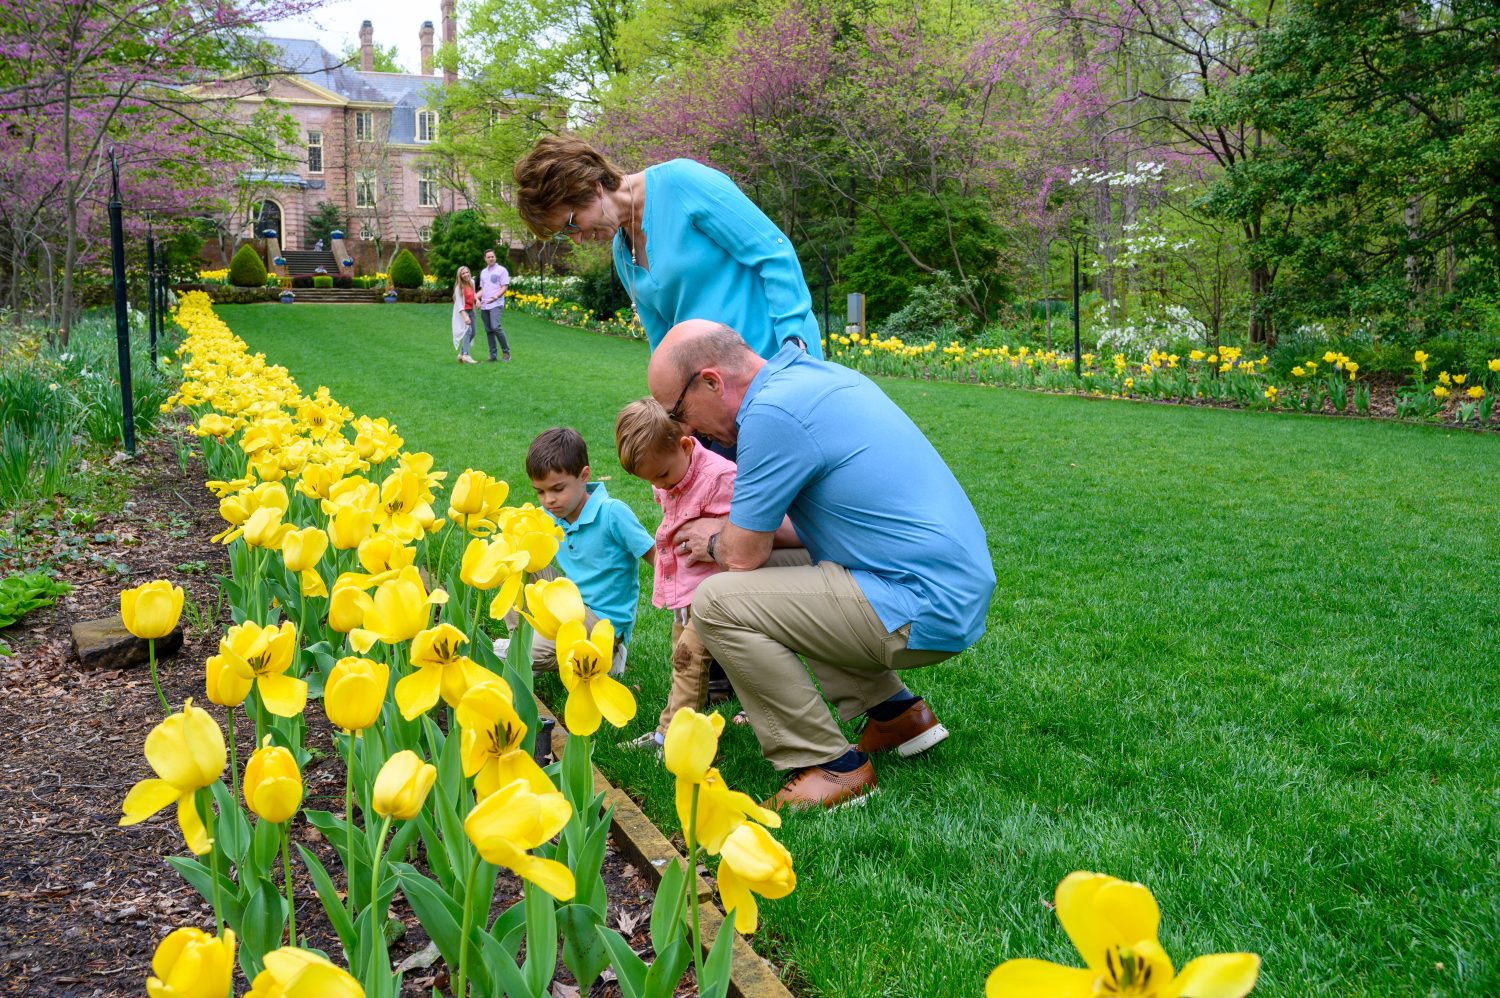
984 870 1260 998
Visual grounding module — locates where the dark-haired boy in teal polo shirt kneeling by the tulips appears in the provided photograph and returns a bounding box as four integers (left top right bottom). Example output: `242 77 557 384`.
527 426 656 675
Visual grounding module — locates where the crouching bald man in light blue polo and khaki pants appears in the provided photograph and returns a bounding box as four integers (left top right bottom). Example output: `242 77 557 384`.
647 320 995 807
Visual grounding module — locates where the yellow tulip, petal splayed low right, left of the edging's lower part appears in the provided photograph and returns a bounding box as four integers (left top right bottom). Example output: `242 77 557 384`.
464 780 578 900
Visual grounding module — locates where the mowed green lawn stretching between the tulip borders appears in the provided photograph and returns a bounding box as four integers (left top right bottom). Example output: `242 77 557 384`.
221 305 1500 998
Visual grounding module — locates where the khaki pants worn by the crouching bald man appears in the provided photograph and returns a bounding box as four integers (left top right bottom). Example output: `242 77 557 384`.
693 548 957 770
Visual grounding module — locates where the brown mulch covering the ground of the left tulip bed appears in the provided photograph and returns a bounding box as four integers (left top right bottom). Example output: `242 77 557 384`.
0 438 669 995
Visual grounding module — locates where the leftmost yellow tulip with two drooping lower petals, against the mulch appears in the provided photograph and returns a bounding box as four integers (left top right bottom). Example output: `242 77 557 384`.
120 698 228 855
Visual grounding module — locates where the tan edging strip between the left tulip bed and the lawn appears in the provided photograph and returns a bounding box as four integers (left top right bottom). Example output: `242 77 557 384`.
537 701 792 998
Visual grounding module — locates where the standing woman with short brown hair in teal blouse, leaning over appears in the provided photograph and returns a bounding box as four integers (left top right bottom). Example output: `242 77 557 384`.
515 135 822 359
